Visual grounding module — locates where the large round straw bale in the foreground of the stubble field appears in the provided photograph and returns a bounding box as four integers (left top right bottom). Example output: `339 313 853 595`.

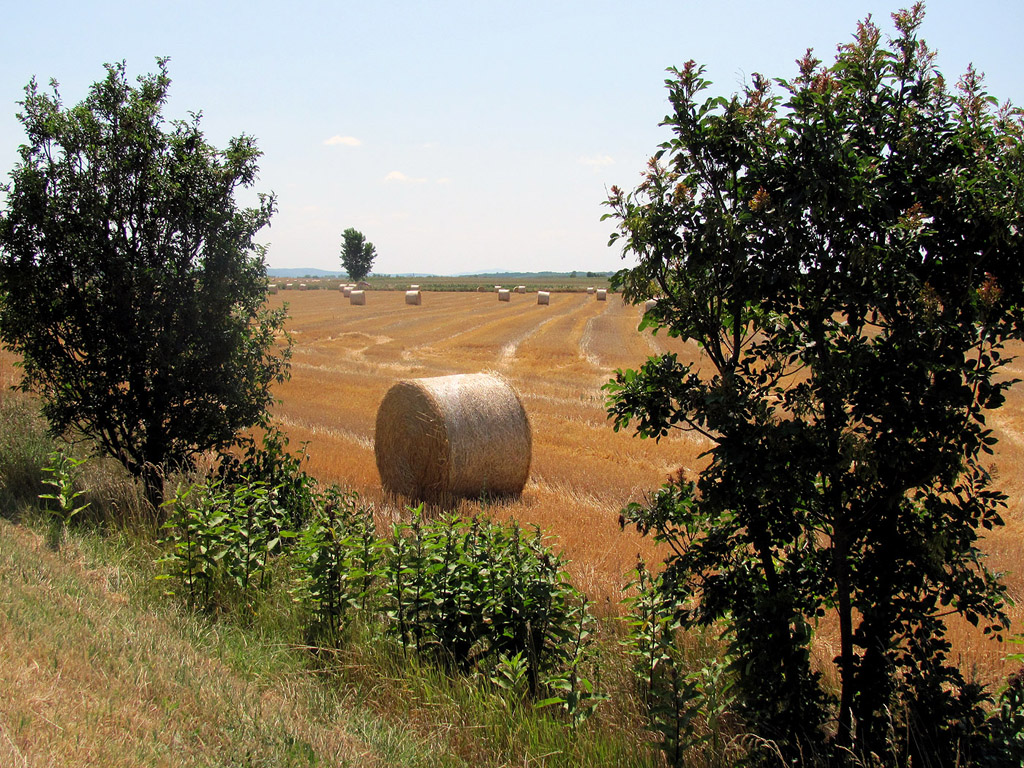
374 374 532 502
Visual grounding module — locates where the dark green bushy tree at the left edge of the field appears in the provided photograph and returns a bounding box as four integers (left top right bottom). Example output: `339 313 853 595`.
0 59 289 504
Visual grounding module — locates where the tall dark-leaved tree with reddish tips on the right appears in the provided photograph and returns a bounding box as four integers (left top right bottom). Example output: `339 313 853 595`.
606 4 1024 765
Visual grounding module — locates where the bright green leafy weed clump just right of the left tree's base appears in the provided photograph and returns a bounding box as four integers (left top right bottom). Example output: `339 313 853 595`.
159 480 295 610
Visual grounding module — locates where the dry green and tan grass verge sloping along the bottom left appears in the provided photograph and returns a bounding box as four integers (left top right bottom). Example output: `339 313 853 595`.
0 397 660 768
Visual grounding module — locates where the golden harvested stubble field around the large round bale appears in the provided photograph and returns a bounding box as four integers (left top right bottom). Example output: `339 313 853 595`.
270 291 1024 678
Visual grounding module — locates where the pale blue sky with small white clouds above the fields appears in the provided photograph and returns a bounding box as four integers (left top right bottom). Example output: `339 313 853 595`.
0 0 1024 274
